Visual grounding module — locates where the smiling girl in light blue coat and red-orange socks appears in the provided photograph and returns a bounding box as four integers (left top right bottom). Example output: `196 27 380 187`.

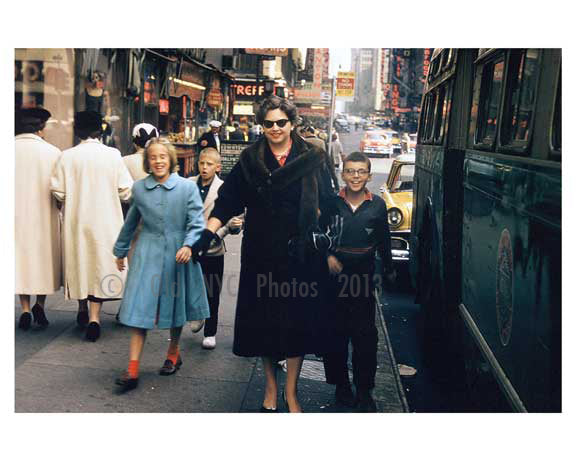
114 139 210 391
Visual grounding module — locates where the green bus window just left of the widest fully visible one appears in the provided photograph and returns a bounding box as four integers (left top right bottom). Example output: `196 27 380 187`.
476 56 504 146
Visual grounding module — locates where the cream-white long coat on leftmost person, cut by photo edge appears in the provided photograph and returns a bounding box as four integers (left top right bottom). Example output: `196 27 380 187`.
14 133 62 295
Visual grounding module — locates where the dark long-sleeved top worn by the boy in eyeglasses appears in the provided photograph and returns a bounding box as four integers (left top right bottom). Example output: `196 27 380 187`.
320 192 392 274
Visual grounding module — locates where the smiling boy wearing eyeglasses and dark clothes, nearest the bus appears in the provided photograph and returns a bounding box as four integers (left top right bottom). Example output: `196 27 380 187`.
322 152 396 412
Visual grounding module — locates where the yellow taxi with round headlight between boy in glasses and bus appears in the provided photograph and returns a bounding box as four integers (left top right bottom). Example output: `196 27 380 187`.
380 154 416 263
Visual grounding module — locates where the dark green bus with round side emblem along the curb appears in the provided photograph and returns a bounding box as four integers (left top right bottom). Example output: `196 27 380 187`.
410 48 562 412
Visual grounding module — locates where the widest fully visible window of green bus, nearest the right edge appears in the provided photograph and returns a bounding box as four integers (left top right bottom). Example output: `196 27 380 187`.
501 50 540 148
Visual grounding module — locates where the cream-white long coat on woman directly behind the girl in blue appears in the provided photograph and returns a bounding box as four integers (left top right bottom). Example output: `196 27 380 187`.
51 139 133 299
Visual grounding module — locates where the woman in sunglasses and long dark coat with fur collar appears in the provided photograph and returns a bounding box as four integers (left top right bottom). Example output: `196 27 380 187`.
192 96 333 412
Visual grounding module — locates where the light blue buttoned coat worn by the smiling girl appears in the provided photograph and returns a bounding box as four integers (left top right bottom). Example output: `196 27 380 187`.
114 173 210 329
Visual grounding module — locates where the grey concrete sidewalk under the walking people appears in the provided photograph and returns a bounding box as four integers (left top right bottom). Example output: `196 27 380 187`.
15 236 408 413
